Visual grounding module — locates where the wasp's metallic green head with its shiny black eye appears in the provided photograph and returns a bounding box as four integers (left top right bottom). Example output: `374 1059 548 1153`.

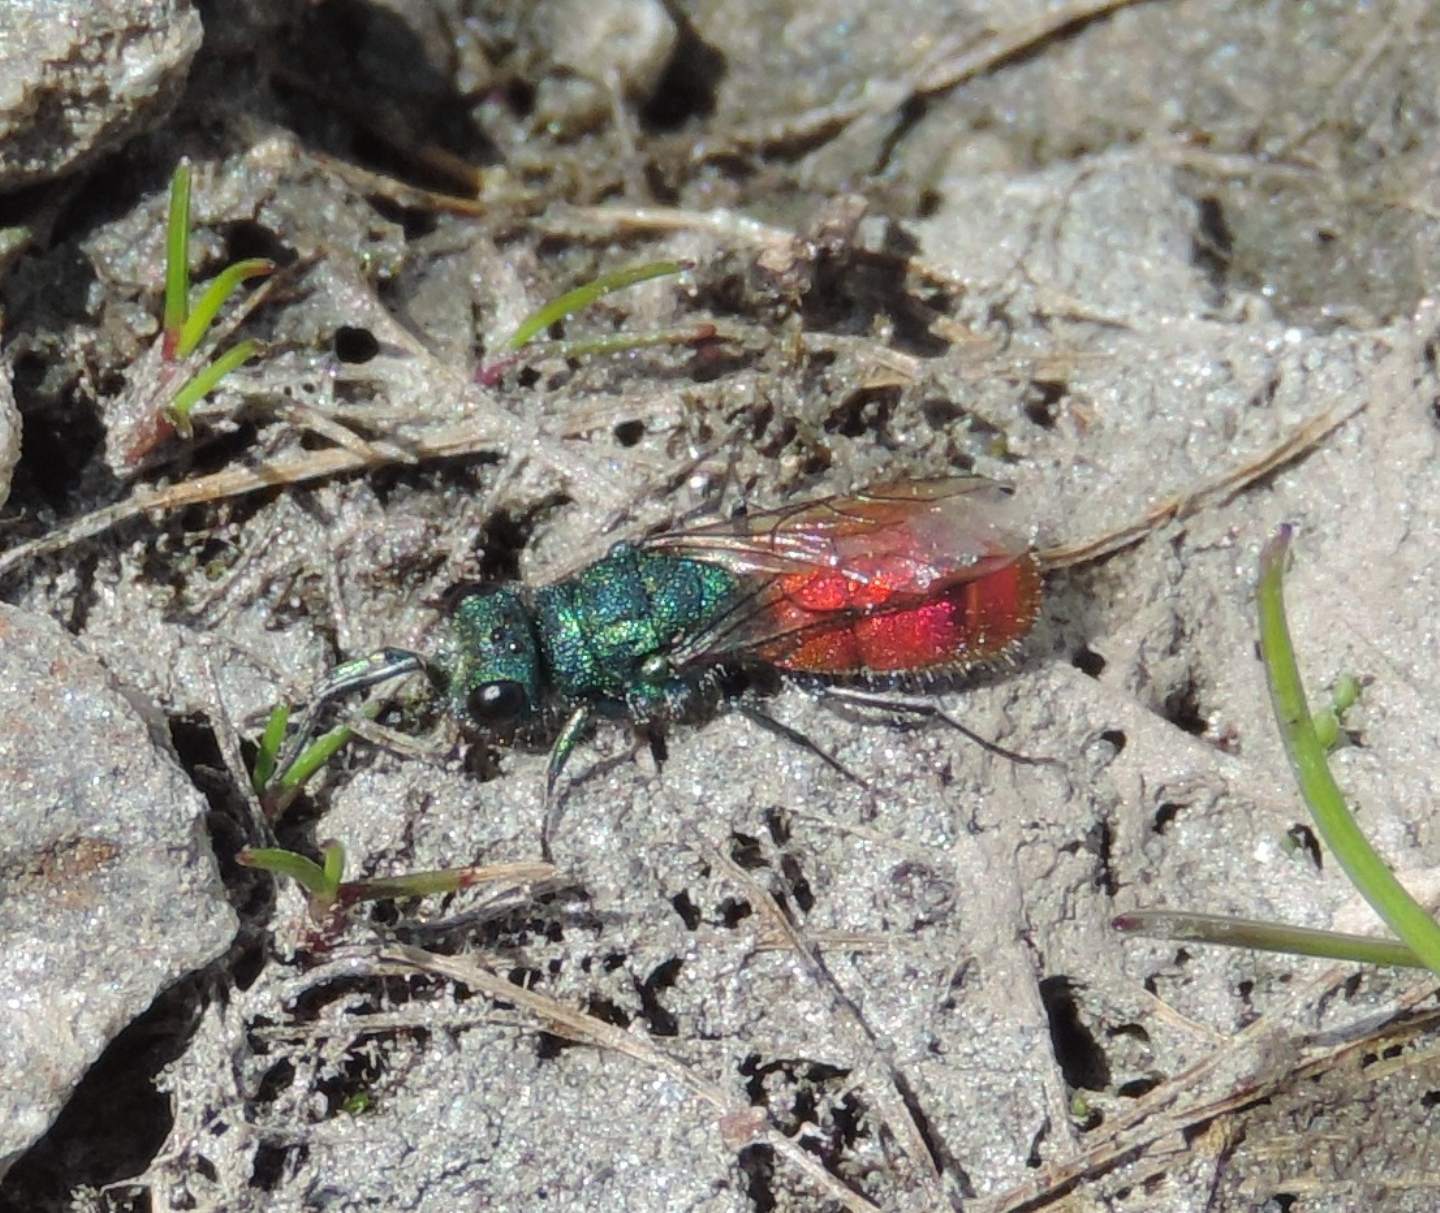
431 586 540 733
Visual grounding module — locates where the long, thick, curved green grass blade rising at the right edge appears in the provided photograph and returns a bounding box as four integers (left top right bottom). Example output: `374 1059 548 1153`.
1256 526 1440 974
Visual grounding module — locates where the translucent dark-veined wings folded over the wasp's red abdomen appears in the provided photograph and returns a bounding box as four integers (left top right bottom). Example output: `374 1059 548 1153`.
644 477 1032 673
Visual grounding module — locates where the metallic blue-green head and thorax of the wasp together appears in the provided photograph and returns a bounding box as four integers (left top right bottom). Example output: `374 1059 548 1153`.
432 543 739 725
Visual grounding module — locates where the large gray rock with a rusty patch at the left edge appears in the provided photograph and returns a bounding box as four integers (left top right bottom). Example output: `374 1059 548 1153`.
0 607 236 1170
